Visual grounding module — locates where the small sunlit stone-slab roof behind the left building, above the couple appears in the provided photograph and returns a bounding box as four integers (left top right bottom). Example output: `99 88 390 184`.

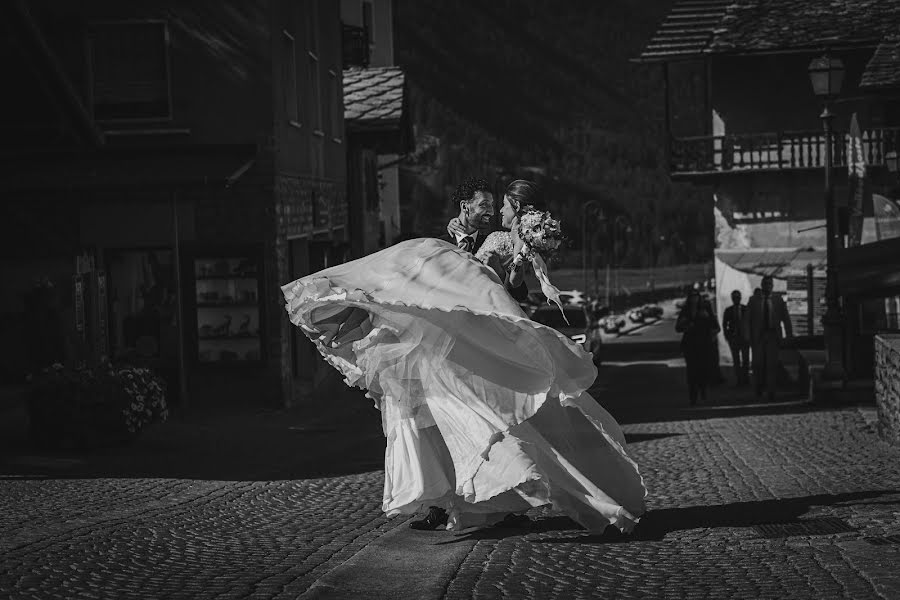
344 67 405 129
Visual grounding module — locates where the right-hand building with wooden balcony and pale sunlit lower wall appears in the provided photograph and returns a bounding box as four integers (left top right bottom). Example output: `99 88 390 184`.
637 0 900 371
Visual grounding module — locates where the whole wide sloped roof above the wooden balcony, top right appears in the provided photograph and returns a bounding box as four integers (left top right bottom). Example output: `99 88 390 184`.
640 0 900 61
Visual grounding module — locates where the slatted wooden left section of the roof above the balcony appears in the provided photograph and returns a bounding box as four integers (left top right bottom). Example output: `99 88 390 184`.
639 0 733 62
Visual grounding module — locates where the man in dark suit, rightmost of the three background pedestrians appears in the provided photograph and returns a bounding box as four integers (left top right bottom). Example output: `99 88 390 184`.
744 275 793 402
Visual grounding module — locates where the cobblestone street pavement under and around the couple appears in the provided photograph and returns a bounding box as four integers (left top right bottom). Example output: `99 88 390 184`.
0 350 900 599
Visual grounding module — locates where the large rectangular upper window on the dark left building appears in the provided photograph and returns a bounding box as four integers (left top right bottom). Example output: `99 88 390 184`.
88 22 172 121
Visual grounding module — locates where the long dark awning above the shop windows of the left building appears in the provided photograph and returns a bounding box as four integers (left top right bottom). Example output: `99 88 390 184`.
0 144 257 191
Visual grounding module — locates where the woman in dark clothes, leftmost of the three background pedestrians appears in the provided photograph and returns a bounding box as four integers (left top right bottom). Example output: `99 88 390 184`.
675 290 720 406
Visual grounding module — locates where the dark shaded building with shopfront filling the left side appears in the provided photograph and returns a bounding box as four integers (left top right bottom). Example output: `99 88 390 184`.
0 0 349 406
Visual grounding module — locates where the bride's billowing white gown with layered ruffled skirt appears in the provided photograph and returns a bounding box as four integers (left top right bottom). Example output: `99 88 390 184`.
282 238 646 531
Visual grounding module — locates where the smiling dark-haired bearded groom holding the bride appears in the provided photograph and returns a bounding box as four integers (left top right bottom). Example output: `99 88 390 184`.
440 177 528 302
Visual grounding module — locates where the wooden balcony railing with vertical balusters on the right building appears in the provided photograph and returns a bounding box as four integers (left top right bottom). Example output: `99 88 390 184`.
670 127 900 175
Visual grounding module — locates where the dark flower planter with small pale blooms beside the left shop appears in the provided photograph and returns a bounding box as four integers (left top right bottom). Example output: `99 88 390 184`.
28 363 168 449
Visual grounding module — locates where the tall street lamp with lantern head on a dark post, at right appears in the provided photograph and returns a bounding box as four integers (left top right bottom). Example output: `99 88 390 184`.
808 52 844 380
